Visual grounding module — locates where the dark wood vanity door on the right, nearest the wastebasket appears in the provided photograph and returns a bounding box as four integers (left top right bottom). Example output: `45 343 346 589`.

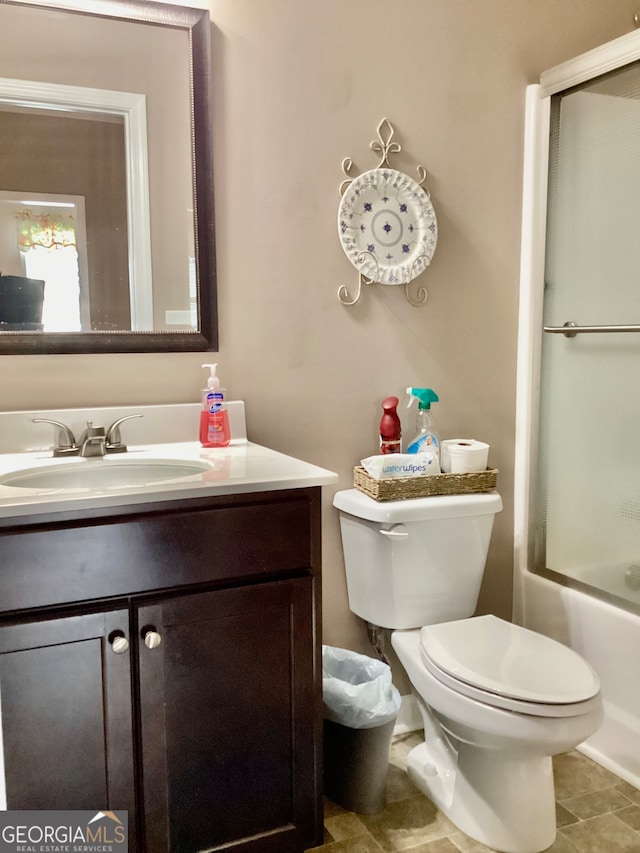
138 578 319 853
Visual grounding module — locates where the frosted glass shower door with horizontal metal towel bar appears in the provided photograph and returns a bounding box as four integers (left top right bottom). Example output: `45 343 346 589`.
534 63 640 606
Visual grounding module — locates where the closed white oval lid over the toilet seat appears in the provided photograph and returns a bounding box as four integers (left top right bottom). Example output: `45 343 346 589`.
420 616 600 705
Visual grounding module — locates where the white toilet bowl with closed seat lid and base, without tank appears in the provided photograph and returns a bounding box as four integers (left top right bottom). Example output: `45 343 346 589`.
391 616 603 853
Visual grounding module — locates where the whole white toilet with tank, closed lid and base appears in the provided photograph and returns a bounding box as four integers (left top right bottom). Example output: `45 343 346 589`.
333 489 603 853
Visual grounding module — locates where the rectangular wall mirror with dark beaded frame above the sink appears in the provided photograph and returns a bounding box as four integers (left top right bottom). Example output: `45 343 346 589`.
0 0 215 352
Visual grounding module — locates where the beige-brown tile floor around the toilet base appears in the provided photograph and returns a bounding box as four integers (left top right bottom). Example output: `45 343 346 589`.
308 733 640 853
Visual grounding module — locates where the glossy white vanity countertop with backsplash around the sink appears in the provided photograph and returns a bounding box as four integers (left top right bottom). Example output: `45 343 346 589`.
0 402 338 519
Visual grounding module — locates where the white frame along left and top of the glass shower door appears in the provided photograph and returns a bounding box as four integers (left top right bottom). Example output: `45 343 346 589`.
513 30 640 624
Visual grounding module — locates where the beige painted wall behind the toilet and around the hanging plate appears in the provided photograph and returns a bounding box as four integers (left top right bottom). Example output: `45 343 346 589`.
0 0 637 660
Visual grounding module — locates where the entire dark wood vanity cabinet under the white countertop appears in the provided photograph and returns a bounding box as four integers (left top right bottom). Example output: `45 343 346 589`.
0 488 322 853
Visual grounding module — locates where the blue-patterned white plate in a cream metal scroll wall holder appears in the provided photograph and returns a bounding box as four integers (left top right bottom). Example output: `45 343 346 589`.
338 118 438 307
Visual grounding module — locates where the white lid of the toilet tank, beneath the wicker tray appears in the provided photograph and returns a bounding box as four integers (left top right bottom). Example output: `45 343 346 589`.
333 489 502 524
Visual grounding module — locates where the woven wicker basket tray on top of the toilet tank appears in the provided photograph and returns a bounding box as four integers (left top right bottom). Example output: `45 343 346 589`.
353 465 498 501
